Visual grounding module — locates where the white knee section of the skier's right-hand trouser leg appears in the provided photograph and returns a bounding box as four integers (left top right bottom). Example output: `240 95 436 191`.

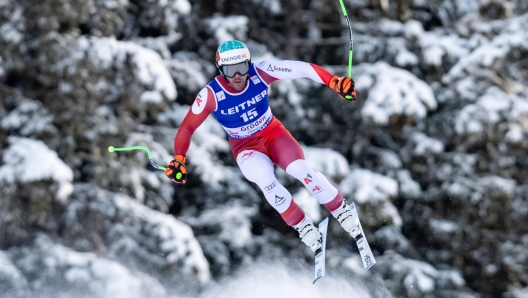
286 159 338 204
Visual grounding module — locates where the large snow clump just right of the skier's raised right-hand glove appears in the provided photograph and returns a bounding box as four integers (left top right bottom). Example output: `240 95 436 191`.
356 61 437 125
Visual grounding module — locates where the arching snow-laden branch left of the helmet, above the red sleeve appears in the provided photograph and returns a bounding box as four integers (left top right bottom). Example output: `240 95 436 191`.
87 37 177 100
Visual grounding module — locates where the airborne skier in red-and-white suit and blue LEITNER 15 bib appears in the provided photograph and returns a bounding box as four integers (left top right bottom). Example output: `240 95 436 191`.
165 40 360 252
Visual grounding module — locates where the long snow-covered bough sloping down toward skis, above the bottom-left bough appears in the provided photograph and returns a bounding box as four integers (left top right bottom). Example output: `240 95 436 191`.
65 184 211 284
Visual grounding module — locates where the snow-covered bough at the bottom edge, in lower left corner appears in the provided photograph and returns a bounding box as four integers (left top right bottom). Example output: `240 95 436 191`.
13 235 167 298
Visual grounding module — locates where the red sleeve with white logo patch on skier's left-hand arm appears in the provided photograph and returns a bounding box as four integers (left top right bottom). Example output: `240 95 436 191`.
174 87 216 155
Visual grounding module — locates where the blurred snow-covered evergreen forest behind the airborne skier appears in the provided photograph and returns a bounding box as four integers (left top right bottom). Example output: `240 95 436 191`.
0 0 528 298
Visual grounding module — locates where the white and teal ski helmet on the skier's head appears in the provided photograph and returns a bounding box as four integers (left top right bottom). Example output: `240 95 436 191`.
216 40 251 77
